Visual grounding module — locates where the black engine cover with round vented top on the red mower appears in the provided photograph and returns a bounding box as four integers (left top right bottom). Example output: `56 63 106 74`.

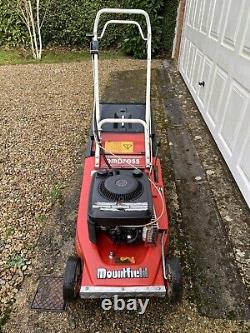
88 169 153 226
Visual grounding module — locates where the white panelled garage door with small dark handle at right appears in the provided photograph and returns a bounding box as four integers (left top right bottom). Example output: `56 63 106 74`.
179 0 250 206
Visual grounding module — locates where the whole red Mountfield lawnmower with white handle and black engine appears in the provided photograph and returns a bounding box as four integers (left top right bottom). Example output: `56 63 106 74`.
63 8 182 302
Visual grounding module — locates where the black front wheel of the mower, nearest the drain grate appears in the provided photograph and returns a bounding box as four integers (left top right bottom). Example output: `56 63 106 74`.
63 256 82 302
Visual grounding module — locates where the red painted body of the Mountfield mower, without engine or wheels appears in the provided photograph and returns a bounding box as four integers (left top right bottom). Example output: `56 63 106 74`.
76 133 168 286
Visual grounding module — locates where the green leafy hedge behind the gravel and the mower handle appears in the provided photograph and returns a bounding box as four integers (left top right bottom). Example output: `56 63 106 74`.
0 0 178 58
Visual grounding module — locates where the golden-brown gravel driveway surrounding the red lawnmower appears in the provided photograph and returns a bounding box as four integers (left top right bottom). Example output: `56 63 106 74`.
0 59 247 333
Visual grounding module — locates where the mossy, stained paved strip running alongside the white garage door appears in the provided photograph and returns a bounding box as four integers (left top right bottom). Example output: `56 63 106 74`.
159 65 250 319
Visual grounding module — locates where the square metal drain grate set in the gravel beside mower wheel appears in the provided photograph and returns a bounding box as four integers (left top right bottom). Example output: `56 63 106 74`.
31 276 65 311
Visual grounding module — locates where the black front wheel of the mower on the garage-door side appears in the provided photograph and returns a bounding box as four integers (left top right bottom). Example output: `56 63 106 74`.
166 257 183 304
